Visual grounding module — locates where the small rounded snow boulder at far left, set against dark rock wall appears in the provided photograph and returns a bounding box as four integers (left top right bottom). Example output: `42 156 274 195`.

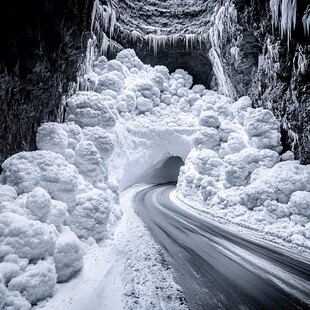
36 122 68 154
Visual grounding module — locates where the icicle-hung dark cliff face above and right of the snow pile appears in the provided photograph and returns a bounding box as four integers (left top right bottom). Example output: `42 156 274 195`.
93 0 310 163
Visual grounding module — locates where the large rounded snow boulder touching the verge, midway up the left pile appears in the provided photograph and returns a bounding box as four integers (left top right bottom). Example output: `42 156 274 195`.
66 189 112 240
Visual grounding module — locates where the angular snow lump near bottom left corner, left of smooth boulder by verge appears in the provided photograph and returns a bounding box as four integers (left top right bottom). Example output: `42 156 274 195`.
8 259 57 304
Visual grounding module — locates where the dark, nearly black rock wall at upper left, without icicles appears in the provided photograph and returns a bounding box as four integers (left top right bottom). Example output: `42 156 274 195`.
0 0 93 167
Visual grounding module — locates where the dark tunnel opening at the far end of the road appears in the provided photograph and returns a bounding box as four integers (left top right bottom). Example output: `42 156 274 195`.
141 156 184 184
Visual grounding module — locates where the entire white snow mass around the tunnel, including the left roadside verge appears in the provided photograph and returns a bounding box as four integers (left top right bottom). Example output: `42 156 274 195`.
0 45 310 310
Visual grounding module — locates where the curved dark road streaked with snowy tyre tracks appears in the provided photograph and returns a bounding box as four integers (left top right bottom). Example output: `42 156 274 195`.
133 185 310 310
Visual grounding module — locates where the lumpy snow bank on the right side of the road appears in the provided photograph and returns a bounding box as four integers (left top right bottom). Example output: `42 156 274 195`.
177 96 310 247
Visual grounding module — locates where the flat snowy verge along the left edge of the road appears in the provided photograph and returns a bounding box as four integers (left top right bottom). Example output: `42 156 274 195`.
34 184 187 310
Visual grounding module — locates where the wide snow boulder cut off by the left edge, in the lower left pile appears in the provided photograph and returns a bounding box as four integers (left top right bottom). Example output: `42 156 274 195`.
0 212 57 259
